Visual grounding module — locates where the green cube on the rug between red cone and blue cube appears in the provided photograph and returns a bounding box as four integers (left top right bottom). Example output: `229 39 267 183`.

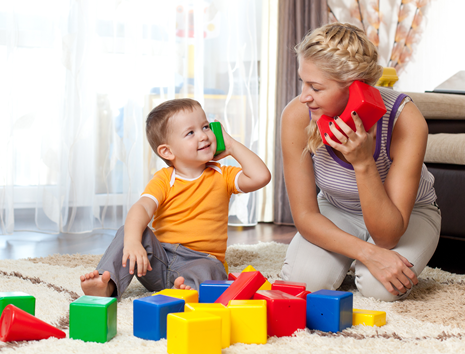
69 296 117 343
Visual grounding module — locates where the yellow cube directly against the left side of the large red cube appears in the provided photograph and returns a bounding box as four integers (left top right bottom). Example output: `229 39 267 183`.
228 300 267 344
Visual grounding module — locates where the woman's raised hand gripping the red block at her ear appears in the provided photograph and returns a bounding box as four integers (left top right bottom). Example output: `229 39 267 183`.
325 111 376 165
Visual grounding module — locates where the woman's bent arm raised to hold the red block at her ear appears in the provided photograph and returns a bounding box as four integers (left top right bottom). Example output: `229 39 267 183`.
326 103 428 249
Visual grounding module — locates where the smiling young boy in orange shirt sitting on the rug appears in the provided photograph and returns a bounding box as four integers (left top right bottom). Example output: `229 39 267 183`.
81 99 271 299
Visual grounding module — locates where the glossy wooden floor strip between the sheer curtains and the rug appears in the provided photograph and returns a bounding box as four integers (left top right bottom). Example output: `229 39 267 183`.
0 223 297 259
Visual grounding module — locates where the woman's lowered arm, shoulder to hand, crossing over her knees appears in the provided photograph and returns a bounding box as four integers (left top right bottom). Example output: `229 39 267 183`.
281 98 418 295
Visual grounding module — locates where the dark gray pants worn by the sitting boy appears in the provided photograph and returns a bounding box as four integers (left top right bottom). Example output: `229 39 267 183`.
97 226 227 299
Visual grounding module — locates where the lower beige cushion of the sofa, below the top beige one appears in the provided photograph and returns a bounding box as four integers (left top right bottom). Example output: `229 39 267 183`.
425 133 465 165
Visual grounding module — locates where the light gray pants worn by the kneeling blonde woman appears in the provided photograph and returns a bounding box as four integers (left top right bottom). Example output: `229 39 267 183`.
281 198 441 301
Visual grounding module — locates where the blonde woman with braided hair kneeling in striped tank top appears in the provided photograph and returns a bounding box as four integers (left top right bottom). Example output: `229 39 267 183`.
281 23 441 301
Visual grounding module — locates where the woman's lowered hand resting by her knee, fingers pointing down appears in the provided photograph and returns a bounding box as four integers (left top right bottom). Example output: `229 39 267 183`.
362 243 418 295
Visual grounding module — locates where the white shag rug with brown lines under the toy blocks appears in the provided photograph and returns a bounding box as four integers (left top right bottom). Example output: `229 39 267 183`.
0 242 465 354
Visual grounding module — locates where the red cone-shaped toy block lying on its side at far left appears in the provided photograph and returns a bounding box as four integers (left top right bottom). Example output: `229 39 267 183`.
0 305 66 342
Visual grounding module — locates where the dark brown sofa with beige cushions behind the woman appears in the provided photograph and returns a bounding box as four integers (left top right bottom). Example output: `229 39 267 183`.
405 92 465 274
